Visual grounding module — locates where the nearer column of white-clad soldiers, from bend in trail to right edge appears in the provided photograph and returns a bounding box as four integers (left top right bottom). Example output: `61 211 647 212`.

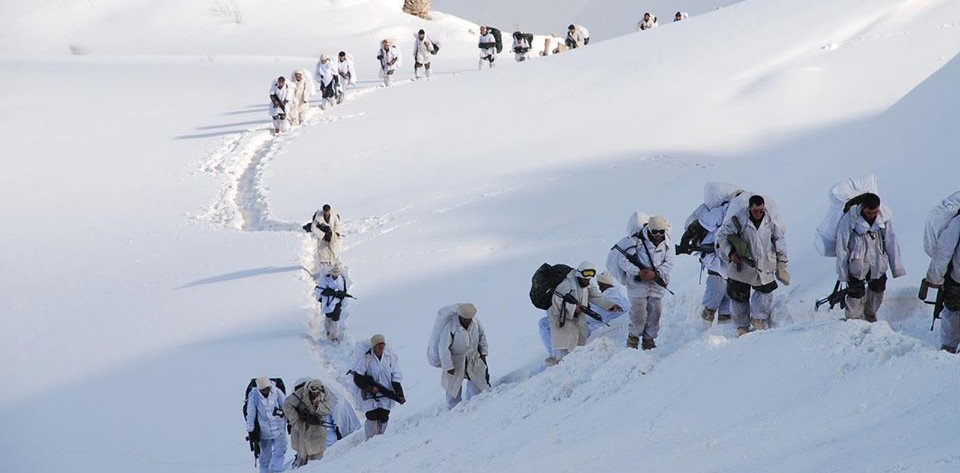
244 181 960 471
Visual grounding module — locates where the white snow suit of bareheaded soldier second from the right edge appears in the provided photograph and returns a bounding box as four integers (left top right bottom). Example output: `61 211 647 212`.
837 205 906 321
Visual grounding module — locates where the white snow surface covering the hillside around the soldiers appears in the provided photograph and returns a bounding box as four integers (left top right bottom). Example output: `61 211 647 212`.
0 0 960 473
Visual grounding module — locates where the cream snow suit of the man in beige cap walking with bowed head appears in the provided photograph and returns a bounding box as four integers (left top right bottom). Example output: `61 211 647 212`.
437 317 490 408
